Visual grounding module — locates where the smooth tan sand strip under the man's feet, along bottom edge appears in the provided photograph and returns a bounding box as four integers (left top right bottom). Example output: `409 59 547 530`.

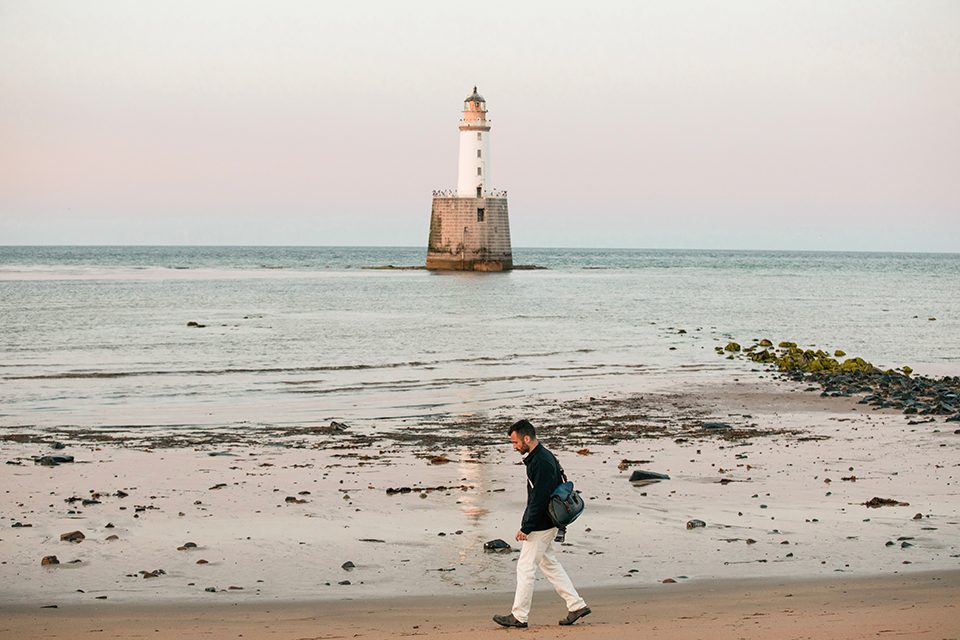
0 570 960 640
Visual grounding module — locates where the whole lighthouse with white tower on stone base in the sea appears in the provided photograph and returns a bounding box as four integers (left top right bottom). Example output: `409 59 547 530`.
427 87 513 271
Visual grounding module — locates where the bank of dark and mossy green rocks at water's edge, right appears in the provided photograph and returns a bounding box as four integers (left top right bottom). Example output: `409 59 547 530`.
716 340 960 422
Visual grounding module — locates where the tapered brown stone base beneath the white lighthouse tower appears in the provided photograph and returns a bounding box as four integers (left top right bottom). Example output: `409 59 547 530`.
427 198 513 271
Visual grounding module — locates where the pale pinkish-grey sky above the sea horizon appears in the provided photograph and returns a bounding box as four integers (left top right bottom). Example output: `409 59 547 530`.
0 0 960 252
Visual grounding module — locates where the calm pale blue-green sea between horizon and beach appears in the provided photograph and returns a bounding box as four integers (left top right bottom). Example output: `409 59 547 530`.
0 246 960 431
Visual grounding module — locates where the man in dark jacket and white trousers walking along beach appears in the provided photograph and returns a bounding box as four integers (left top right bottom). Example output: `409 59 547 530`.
493 420 590 628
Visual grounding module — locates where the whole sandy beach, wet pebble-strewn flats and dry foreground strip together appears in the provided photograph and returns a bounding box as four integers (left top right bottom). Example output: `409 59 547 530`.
0 376 960 638
